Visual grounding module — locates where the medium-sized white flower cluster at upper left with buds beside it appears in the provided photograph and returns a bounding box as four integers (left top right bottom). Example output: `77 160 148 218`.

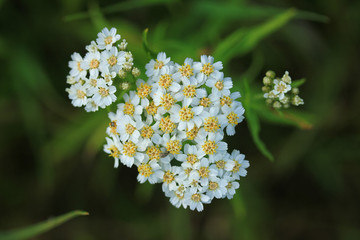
66 28 140 112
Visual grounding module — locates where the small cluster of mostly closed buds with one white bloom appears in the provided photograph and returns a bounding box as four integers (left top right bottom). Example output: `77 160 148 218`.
262 71 304 109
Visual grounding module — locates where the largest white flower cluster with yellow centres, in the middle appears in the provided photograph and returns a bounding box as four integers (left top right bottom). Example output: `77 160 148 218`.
104 53 249 211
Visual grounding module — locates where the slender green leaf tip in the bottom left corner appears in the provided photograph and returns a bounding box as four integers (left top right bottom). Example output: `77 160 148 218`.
0 210 89 240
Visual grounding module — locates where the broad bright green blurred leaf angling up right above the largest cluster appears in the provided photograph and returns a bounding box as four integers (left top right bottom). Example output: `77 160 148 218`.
214 9 297 65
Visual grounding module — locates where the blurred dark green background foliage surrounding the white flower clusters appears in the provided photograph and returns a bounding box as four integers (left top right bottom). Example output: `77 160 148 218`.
0 0 360 240
